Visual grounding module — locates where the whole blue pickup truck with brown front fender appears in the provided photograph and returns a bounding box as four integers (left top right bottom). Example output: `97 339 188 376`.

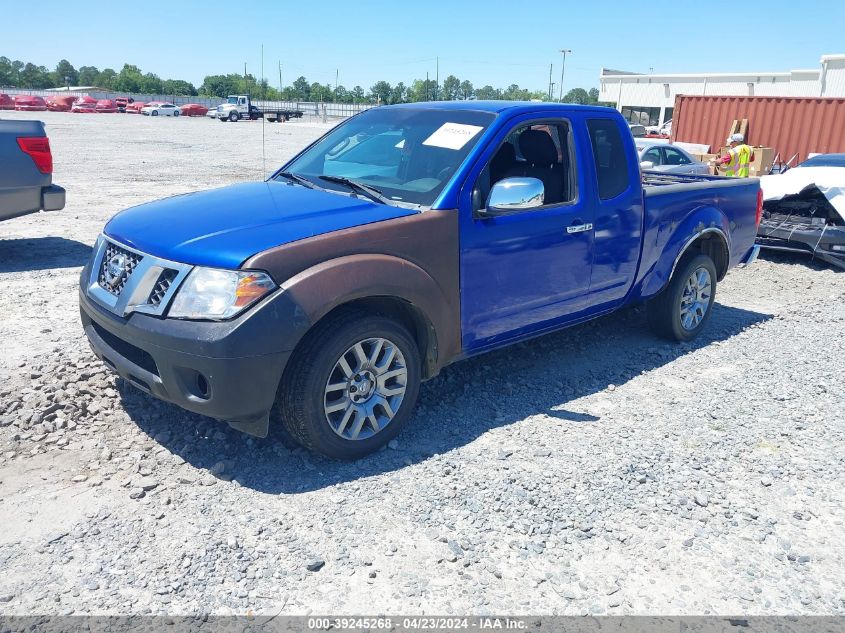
79 101 762 458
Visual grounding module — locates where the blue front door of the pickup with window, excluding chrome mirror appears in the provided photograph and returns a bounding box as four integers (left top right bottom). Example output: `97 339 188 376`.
460 116 594 353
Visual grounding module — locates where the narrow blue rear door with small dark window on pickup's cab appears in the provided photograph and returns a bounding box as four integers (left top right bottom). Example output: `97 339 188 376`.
587 115 643 313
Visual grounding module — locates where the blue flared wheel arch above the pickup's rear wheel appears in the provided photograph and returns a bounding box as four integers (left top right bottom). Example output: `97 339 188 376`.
635 207 731 299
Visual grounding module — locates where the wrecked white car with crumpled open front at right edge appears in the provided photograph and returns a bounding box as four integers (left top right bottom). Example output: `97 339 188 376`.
757 154 845 269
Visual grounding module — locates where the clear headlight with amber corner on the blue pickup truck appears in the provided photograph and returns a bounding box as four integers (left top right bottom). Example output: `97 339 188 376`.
167 267 276 320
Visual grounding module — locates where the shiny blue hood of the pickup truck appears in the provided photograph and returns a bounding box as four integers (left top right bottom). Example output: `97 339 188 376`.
103 182 419 269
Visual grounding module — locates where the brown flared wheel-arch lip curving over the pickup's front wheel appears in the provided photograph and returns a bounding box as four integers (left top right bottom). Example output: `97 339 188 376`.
281 254 460 363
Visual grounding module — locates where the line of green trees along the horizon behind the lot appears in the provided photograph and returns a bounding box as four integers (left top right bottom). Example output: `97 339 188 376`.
0 57 599 104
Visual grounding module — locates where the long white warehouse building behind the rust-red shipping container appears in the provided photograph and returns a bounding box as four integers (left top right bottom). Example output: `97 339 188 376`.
599 55 845 125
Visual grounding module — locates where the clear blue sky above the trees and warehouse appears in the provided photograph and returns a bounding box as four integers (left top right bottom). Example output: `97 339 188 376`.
0 0 845 90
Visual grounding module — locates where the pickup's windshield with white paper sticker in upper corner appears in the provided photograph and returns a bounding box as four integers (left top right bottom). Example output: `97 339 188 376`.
285 107 495 206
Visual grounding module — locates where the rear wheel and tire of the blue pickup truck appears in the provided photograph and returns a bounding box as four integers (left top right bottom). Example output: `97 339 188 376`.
647 254 716 341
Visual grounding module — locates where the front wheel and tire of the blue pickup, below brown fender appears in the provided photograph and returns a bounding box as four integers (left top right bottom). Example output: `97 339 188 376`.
278 310 421 460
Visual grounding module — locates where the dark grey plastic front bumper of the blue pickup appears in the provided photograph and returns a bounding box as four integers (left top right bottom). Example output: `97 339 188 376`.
79 290 292 437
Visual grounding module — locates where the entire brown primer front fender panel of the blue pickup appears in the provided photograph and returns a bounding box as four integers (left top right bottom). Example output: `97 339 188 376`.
241 209 461 375
